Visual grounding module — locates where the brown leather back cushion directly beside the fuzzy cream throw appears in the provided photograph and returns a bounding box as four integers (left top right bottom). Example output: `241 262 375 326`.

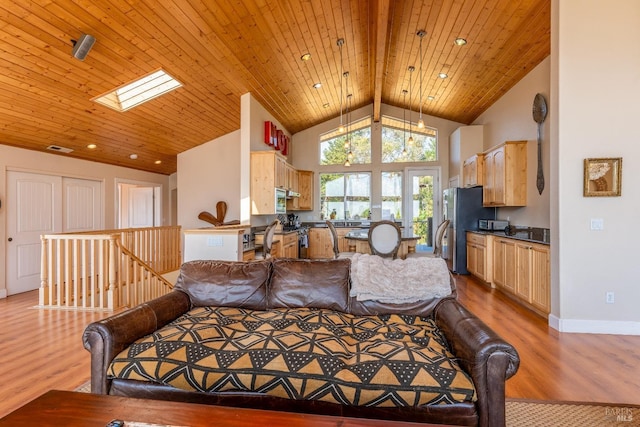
268 259 351 312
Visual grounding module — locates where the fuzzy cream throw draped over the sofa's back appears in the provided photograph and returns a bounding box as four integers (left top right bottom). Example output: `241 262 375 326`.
350 254 451 304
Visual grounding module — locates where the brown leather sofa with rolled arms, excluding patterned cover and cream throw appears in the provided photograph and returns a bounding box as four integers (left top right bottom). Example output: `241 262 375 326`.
83 259 519 427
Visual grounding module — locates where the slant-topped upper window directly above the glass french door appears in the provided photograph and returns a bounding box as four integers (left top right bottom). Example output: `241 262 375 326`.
381 116 438 163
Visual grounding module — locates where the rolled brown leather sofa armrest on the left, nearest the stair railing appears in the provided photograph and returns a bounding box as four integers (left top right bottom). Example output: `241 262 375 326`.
82 290 191 394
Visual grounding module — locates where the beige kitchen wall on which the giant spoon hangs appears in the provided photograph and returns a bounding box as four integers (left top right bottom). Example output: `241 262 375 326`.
473 58 557 228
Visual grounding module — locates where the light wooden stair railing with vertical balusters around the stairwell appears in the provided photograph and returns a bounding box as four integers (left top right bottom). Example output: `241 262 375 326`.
39 227 181 310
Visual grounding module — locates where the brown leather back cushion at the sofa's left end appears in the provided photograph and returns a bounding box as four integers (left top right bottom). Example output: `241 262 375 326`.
176 260 271 310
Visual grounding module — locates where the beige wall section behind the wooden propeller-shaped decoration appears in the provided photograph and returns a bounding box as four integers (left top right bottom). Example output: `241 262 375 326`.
178 130 241 230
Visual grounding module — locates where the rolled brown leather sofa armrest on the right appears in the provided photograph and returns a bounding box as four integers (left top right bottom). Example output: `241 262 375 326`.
434 299 520 427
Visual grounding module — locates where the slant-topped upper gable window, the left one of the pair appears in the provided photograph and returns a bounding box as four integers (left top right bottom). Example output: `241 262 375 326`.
320 117 371 165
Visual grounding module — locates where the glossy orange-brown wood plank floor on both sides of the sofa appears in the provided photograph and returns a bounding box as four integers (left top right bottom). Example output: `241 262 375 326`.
0 276 640 417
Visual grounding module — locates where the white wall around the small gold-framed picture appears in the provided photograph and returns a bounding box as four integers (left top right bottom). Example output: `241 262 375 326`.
551 0 640 334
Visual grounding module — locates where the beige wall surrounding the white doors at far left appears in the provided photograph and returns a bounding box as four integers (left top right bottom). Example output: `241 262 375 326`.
0 145 170 296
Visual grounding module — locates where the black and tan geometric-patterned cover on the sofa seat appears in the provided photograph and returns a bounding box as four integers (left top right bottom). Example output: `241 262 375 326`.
109 307 476 407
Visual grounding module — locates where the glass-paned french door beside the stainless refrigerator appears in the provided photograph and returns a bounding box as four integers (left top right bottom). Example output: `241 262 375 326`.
403 168 442 252
